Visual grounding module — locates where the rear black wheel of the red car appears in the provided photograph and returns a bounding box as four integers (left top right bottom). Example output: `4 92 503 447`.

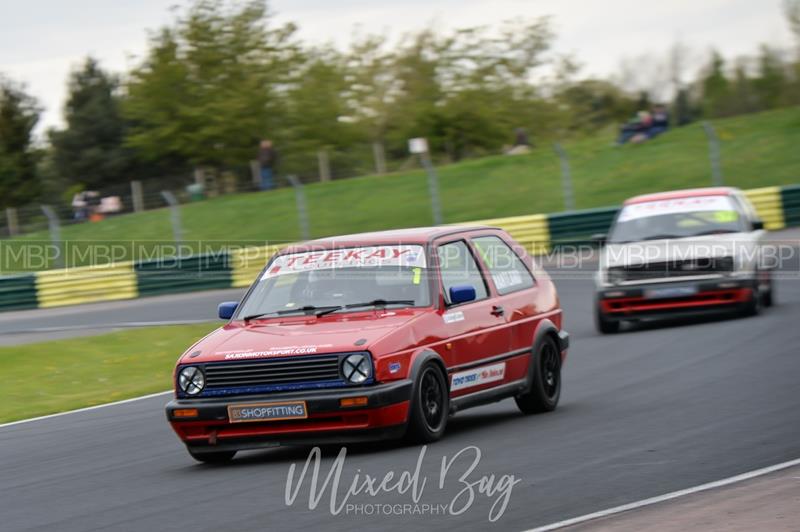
514 336 561 414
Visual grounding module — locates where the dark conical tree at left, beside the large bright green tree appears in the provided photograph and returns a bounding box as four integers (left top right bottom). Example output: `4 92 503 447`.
50 57 132 188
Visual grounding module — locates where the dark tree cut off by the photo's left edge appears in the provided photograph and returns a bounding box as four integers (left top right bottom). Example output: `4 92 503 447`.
0 78 41 207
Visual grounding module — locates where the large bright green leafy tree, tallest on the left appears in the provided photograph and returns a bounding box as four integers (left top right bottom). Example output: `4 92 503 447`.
125 0 298 167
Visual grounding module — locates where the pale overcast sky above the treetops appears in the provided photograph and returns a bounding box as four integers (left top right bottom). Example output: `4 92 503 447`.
0 0 792 132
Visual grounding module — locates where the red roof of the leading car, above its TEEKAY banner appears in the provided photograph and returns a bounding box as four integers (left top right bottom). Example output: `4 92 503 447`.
281 225 498 254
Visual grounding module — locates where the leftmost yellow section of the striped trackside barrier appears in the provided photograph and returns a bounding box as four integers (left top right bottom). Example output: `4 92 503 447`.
36 262 138 308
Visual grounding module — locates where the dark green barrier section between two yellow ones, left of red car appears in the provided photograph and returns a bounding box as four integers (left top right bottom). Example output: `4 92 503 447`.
134 251 231 296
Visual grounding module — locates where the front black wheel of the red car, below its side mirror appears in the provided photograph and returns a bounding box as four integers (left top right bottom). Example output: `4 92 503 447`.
406 362 450 443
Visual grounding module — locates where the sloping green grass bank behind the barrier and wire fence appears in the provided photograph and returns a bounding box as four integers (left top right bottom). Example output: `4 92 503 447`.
0 107 800 271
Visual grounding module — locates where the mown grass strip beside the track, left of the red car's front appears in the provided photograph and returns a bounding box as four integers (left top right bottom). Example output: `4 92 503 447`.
0 323 219 423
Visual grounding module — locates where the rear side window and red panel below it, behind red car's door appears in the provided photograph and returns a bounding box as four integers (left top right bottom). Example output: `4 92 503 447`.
470 234 541 364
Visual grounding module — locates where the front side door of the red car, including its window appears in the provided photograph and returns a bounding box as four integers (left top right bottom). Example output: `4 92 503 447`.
436 239 511 397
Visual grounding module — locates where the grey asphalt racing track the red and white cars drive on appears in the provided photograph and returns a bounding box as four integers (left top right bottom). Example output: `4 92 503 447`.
0 239 800 532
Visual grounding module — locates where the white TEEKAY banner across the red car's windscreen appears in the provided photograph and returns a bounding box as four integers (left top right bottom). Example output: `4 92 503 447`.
262 245 426 279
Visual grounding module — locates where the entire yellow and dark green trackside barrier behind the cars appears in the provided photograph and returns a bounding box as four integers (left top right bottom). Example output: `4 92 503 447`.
0 185 800 312
